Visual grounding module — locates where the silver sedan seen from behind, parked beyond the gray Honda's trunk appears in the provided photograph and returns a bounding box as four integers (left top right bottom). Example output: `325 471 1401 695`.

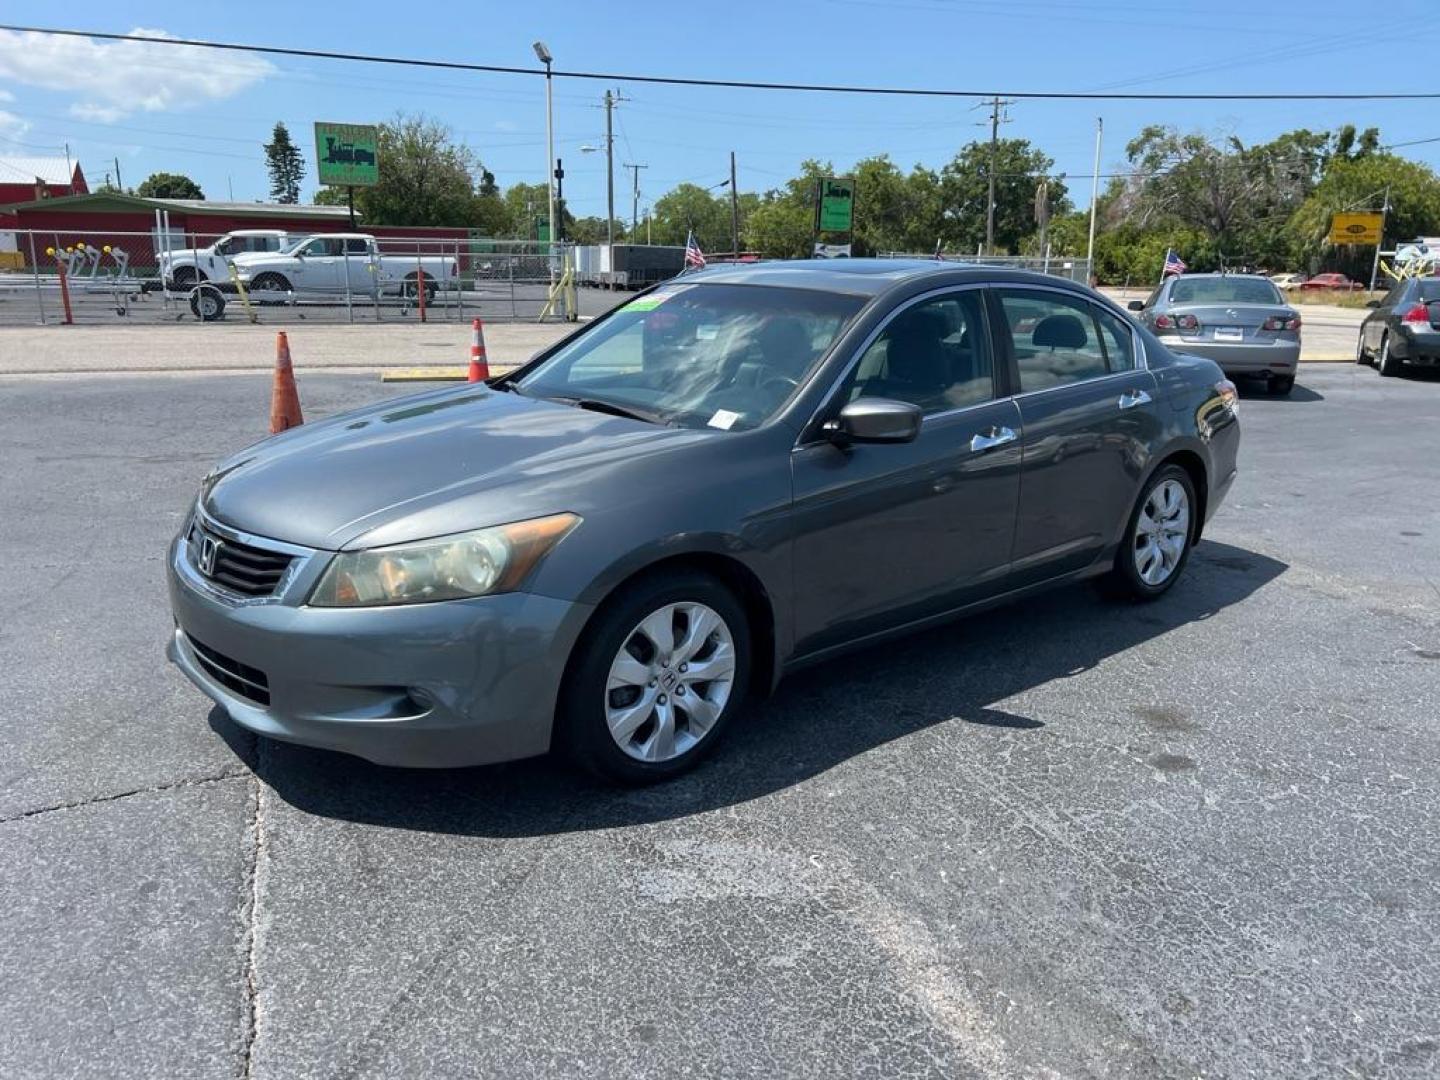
1129 274 1300 395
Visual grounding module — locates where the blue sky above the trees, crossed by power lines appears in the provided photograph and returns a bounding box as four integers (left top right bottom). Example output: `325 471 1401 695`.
0 0 1440 217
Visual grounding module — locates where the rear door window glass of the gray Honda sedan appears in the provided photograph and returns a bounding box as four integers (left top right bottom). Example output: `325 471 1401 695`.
998 289 1109 393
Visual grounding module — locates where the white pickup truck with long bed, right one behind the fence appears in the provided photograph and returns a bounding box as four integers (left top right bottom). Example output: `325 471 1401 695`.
235 232 459 300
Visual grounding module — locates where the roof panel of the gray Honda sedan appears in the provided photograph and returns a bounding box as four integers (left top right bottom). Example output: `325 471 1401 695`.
667 259 1081 297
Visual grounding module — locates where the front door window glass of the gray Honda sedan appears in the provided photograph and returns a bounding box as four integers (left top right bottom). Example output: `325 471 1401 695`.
841 289 995 415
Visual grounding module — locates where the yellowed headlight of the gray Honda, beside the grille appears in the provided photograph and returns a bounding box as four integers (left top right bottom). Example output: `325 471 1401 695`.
310 514 580 608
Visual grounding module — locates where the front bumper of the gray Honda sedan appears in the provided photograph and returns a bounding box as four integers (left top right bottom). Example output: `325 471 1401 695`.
166 536 590 768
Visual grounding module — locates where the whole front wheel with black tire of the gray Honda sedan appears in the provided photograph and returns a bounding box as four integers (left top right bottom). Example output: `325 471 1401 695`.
556 572 752 785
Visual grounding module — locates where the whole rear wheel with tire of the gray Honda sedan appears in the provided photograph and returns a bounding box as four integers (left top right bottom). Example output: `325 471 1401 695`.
1110 465 1200 600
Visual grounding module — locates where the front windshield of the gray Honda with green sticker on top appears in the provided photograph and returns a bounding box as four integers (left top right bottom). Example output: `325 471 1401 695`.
516 282 864 431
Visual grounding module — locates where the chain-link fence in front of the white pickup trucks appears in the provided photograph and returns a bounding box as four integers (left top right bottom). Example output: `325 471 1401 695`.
0 229 576 325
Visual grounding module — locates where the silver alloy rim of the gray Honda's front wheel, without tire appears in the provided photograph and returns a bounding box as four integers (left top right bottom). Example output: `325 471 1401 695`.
605 602 736 762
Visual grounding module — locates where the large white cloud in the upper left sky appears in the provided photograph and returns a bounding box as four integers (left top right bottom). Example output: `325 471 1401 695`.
0 27 275 121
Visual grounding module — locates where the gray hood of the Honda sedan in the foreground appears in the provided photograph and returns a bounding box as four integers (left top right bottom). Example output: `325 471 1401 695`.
202 386 704 550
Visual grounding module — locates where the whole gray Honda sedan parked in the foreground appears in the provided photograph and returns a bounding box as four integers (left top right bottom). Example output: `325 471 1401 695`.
168 259 1240 782
